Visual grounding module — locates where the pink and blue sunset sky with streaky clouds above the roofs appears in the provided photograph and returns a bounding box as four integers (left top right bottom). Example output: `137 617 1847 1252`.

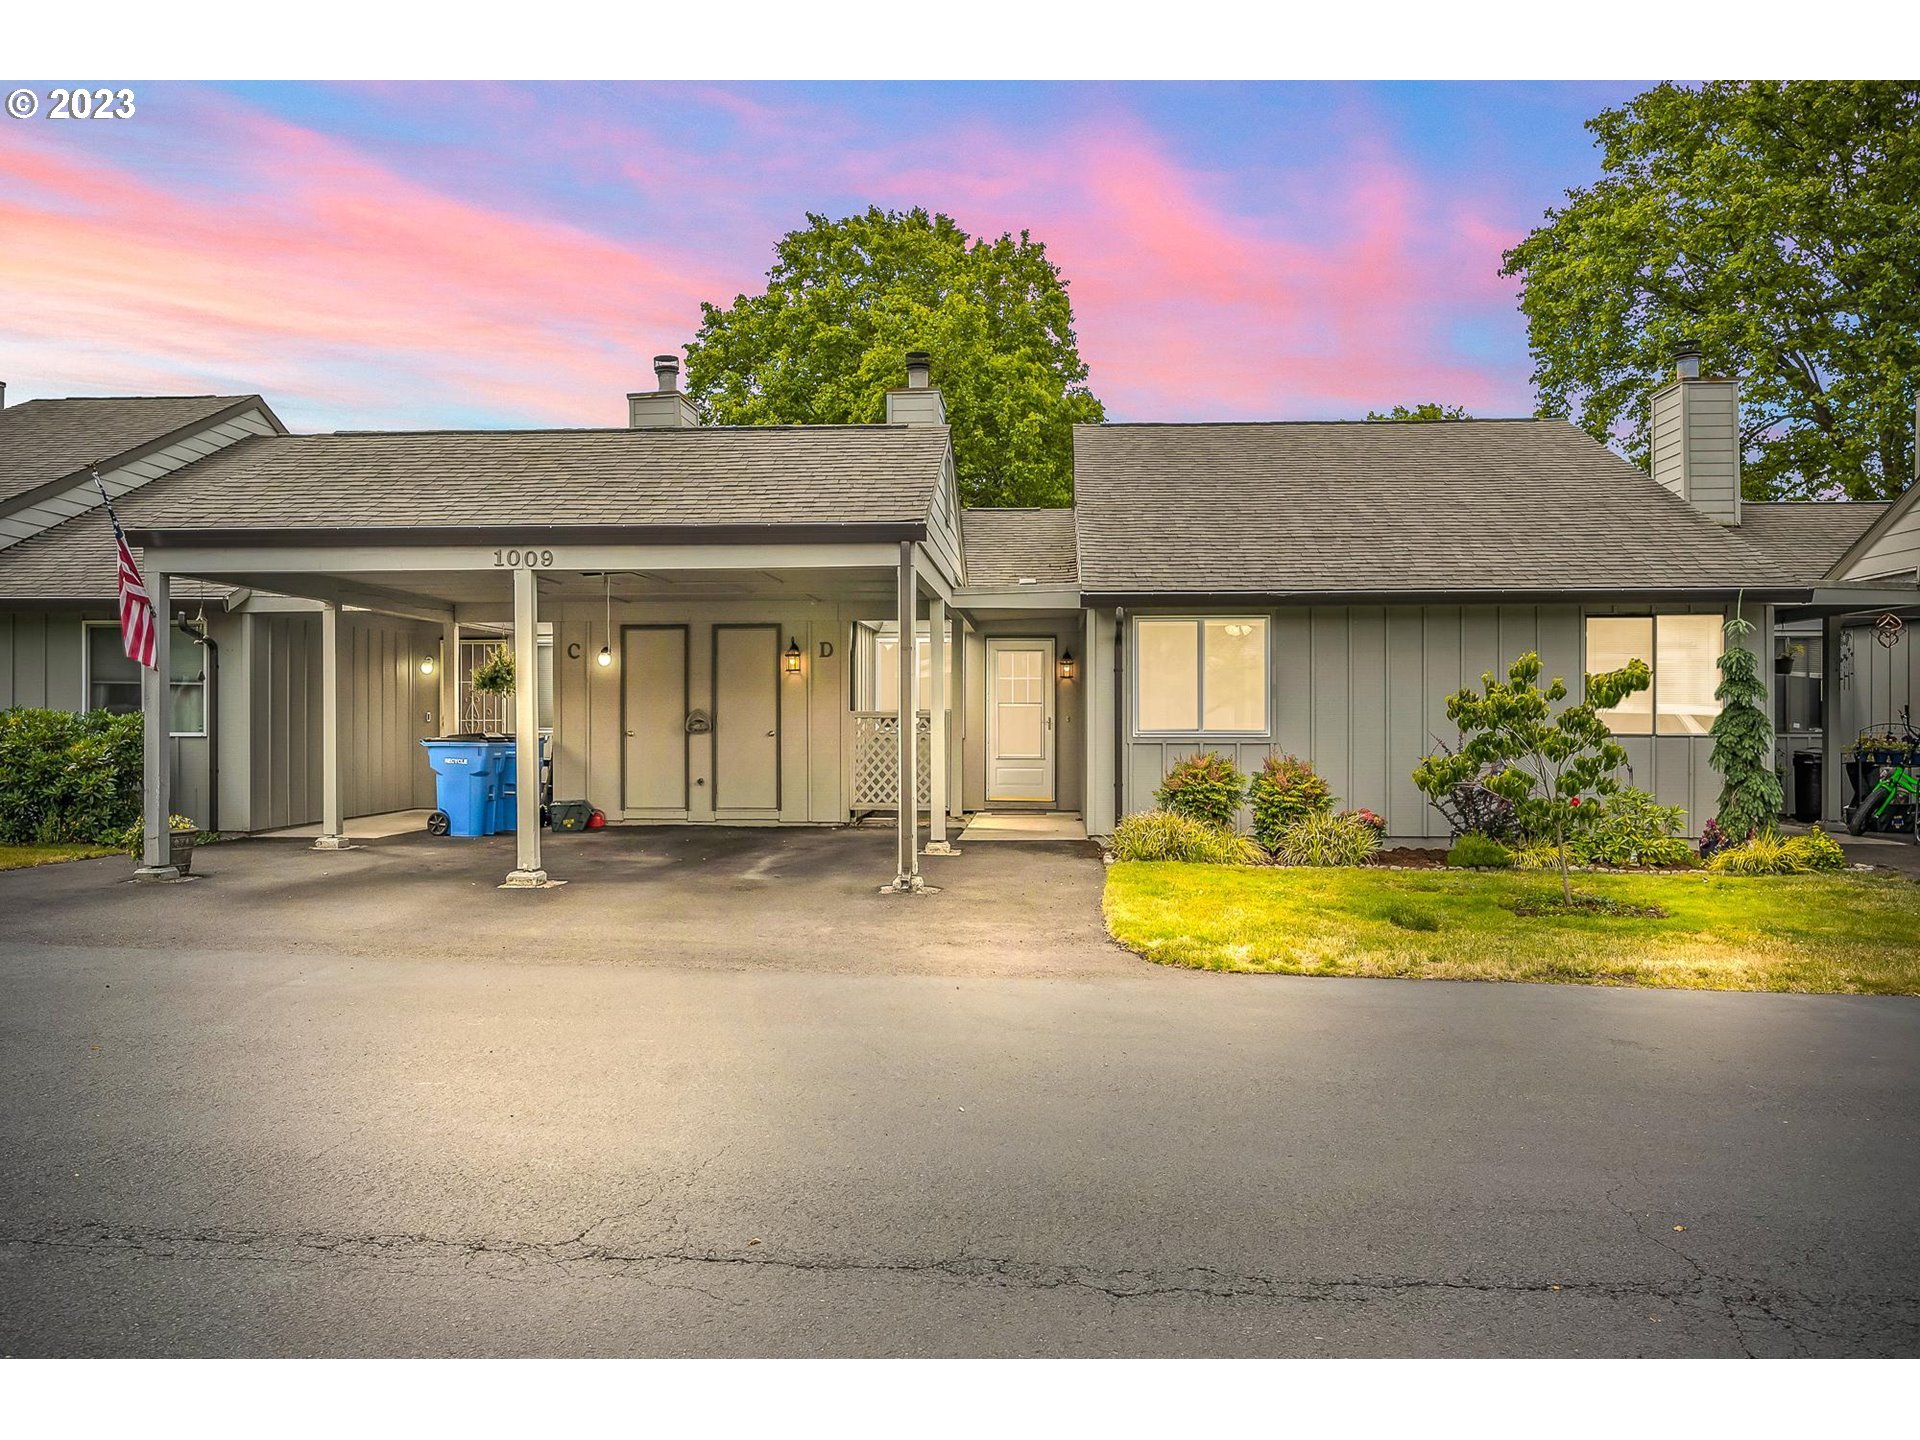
0 83 1645 430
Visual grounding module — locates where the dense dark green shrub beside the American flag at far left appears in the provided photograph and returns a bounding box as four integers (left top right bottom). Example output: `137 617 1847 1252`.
0 708 144 845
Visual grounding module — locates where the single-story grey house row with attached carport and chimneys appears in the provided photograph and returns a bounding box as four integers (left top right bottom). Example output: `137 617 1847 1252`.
0 355 1920 887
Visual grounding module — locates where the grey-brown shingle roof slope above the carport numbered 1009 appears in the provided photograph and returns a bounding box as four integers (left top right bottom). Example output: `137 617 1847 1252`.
121 424 947 530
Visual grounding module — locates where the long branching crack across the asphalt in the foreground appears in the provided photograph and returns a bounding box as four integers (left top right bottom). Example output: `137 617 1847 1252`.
0 1221 1920 1356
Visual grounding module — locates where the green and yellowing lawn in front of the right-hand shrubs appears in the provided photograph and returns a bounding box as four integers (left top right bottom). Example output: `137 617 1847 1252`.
1104 862 1920 995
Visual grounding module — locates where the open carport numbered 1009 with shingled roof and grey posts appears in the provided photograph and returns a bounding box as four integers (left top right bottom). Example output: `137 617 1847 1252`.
116 401 962 891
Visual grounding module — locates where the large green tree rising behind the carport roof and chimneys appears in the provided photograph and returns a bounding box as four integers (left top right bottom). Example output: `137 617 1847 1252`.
687 207 1106 505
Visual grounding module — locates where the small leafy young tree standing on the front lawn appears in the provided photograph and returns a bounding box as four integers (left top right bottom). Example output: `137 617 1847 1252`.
1413 651 1653 900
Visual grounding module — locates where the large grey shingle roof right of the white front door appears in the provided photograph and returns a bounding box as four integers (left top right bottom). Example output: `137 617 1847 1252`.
1073 420 1793 595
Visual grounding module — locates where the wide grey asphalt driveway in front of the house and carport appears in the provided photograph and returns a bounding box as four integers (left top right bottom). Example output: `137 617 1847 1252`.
0 831 1920 1356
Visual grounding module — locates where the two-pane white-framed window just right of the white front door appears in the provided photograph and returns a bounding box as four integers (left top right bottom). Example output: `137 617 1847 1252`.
1133 614 1267 735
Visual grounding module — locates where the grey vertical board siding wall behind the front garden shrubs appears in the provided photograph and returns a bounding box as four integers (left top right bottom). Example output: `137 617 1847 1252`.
1102 603 1770 839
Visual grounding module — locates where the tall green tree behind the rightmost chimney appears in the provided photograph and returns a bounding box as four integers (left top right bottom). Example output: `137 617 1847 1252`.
1501 81 1920 499
